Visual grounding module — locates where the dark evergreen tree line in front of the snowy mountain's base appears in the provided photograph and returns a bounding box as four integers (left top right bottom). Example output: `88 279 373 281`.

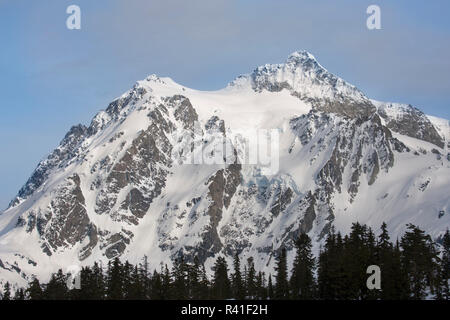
2 223 450 300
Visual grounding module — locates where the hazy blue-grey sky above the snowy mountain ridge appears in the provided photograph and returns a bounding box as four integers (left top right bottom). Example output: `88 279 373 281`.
0 0 450 208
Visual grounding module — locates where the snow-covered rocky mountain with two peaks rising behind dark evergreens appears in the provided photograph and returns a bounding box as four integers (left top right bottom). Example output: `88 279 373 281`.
0 52 450 285
